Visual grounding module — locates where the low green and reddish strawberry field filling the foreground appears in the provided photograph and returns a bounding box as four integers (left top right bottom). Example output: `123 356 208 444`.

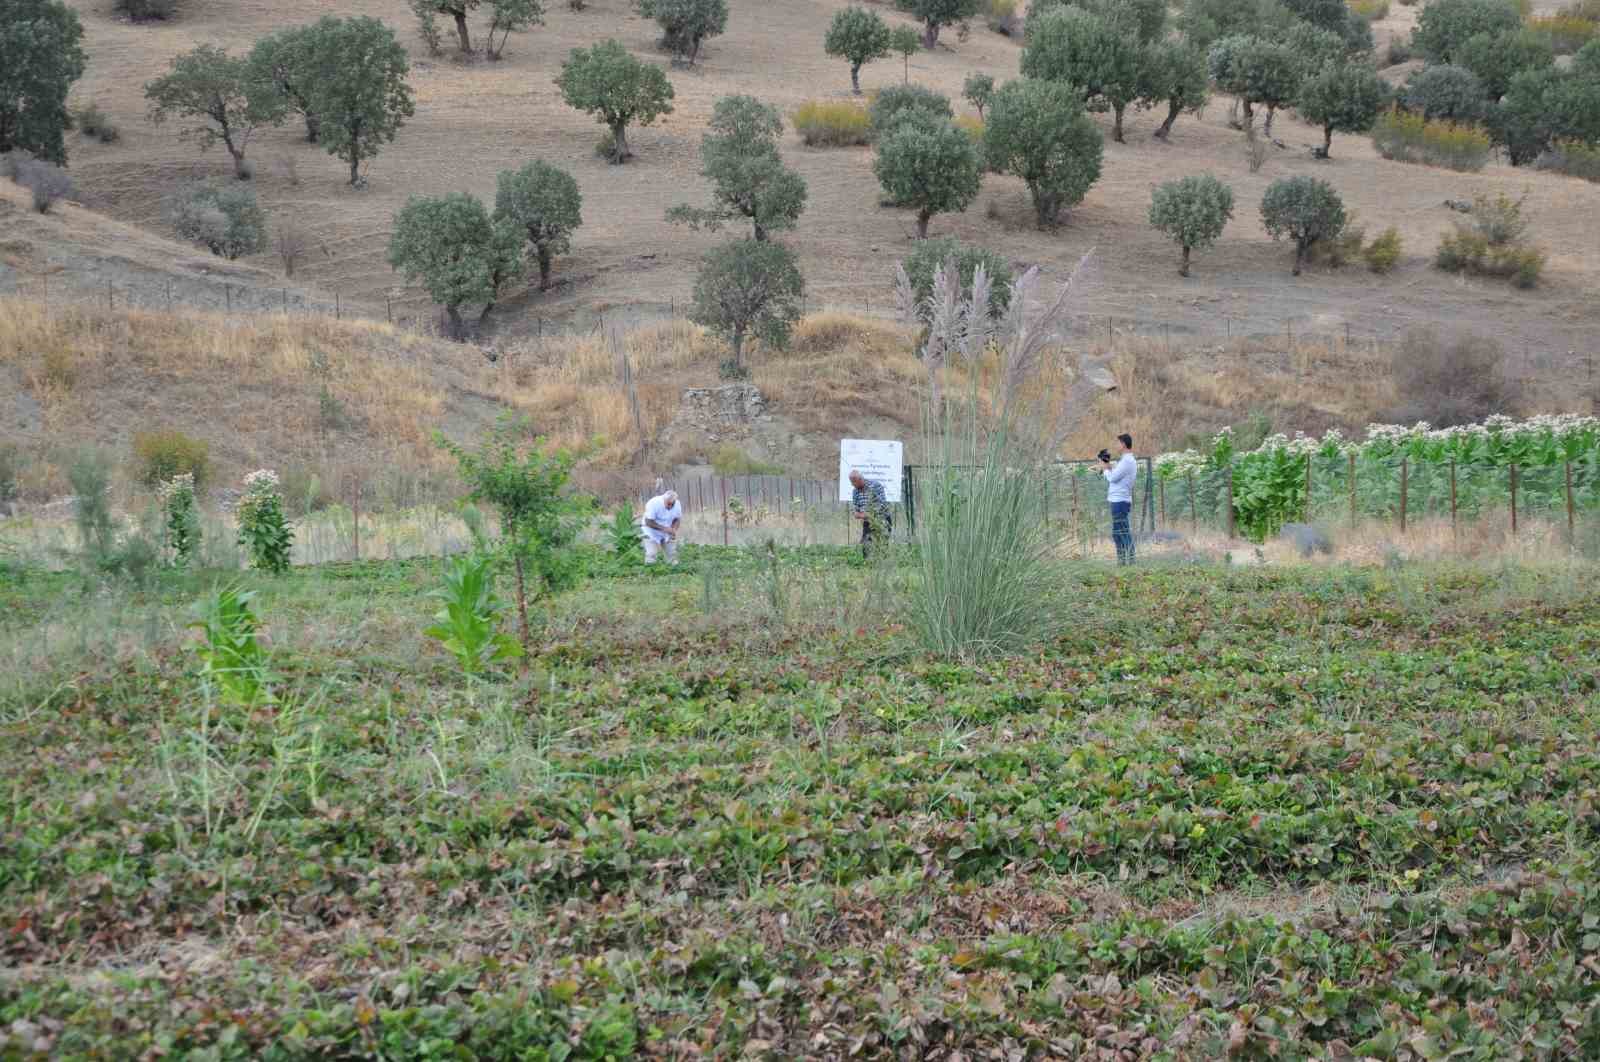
0 549 1600 1060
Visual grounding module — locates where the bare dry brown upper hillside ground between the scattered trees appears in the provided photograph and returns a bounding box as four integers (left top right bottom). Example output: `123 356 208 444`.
43 0 1600 368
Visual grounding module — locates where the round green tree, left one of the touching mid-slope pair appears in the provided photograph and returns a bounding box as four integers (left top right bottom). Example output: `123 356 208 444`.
389 192 526 339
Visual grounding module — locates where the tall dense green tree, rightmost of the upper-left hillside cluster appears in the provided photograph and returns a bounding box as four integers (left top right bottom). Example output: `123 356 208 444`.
310 16 416 186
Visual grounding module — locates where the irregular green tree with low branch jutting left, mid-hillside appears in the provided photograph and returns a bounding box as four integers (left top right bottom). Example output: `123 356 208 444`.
667 96 806 240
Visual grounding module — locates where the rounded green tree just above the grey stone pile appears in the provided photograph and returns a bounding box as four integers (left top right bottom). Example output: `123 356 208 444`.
690 240 805 366
